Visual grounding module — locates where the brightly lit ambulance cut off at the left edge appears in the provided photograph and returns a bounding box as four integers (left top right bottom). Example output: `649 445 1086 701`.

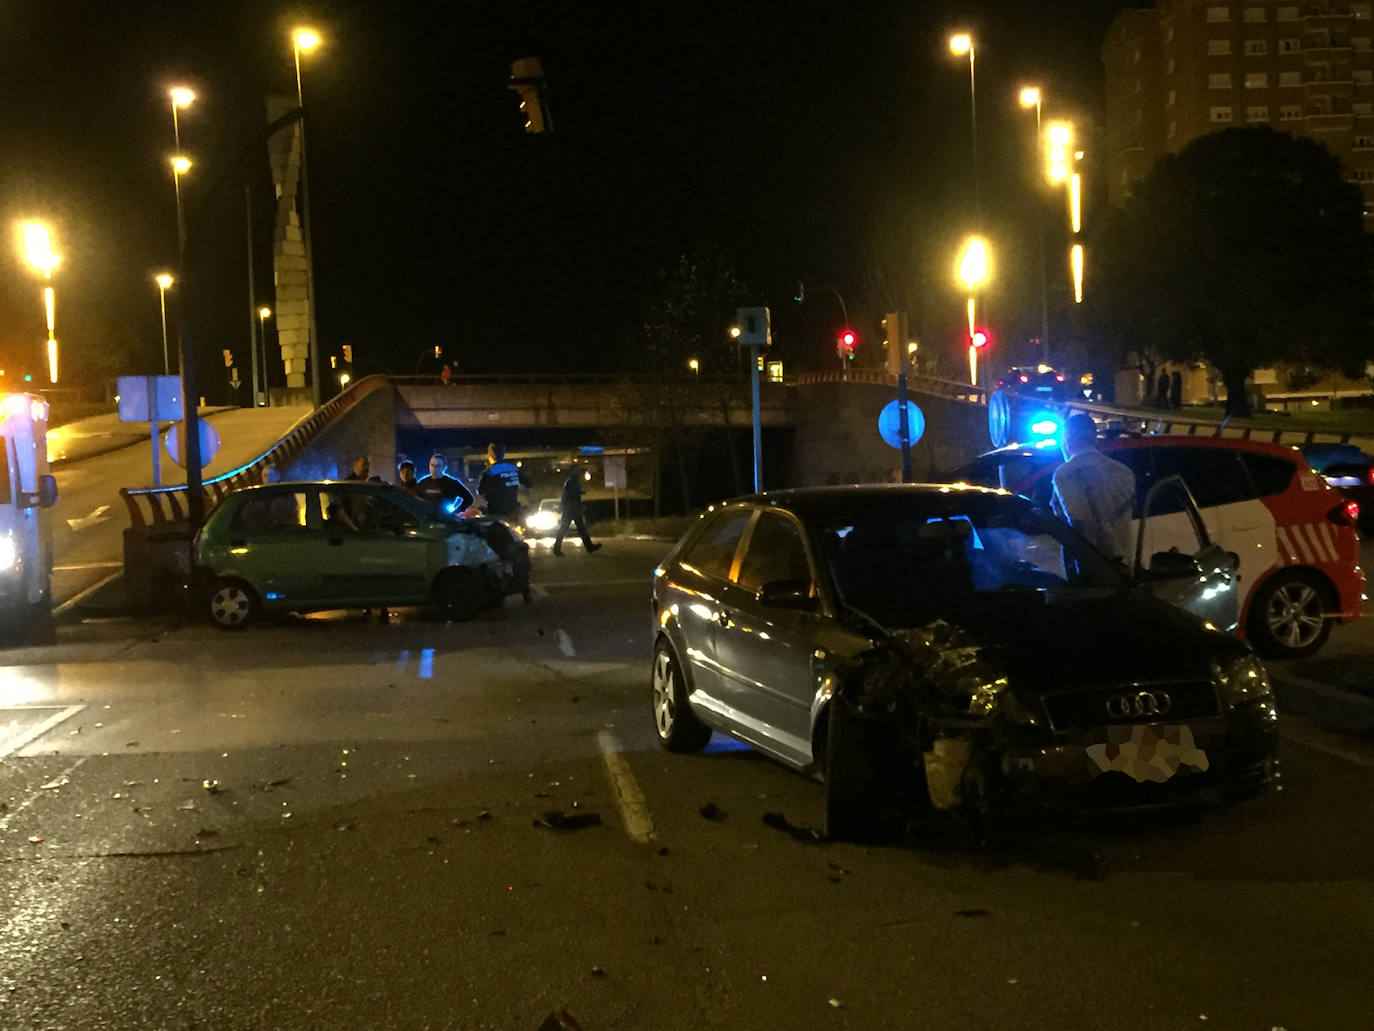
0 393 58 638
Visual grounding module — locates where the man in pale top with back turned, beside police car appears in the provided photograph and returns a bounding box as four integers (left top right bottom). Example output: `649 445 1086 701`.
1050 412 1135 565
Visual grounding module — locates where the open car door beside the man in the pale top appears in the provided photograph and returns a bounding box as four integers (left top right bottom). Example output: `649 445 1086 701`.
1134 474 1241 631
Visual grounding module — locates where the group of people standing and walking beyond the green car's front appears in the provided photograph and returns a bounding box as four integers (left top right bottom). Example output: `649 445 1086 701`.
345 444 600 555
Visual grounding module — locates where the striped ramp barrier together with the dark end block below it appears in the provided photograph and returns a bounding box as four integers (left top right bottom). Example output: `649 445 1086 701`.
120 377 390 612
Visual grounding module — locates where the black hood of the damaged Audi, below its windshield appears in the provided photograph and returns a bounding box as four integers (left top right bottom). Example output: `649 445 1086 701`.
895 590 1245 694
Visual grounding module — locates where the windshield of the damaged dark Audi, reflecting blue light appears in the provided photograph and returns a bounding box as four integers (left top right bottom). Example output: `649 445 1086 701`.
816 491 1127 627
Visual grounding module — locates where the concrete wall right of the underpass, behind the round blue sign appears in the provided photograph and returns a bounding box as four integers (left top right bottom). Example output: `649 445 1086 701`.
787 384 992 487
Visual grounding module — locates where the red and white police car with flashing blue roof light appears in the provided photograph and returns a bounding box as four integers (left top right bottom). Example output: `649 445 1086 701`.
944 436 1364 658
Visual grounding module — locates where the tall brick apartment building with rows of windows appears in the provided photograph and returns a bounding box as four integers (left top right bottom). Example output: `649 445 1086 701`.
1102 0 1374 219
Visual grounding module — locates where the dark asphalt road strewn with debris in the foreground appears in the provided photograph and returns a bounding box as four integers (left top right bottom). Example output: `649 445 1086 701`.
0 540 1374 1031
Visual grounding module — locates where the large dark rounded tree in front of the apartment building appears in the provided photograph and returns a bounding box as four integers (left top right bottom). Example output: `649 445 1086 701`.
1085 126 1371 415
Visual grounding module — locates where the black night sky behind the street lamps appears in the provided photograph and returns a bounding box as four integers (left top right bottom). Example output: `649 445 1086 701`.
0 0 1147 395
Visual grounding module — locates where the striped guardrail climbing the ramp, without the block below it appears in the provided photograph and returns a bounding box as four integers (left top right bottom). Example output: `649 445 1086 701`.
120 375 390 531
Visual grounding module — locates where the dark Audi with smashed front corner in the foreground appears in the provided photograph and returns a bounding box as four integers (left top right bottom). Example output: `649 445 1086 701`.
651 485 1278 837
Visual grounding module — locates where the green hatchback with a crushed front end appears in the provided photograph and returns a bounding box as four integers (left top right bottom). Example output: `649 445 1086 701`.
195 481 530 630
